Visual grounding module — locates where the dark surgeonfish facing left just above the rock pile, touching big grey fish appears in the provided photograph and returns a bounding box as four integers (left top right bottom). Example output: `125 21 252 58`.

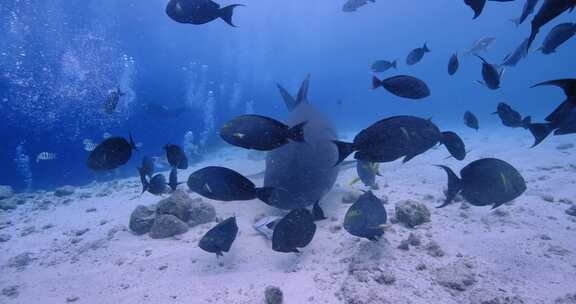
187 166 274 204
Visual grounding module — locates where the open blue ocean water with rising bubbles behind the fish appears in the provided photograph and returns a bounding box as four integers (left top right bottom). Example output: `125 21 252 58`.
0 0 576 190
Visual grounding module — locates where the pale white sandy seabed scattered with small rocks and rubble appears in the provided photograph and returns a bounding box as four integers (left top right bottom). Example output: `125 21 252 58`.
0 128 576 304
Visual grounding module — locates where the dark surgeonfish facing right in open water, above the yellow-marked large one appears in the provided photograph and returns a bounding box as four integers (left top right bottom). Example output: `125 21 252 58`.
372 75 430 99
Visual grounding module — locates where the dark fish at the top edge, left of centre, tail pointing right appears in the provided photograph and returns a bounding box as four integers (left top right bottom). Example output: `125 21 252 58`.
166 0 243 27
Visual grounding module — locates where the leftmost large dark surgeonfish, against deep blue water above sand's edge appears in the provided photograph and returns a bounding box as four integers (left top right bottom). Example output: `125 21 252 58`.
86 135 136 171
